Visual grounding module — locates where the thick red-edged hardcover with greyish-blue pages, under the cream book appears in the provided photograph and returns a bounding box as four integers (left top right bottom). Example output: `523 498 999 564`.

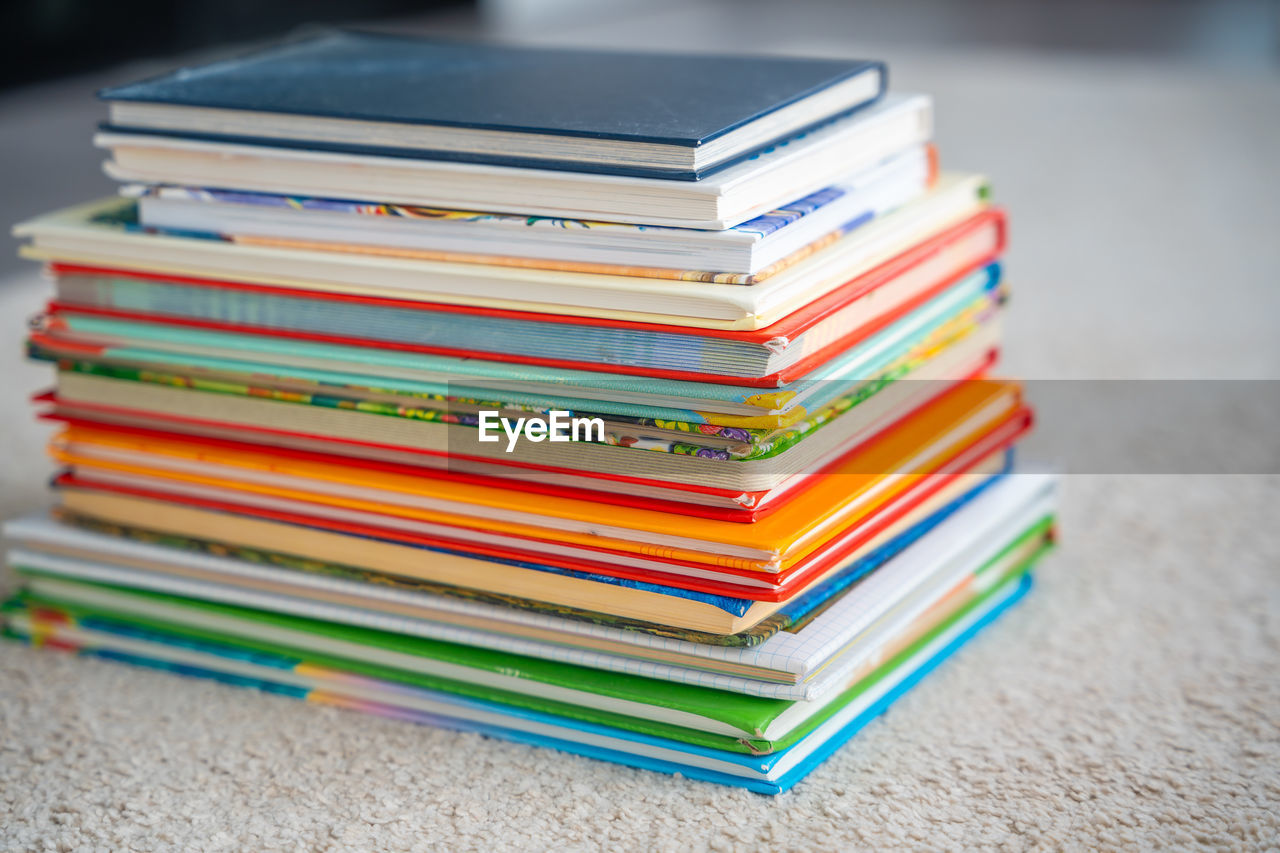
37 209 1005 387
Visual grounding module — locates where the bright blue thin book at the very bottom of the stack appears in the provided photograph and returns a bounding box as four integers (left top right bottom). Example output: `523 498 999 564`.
6 574 1032 794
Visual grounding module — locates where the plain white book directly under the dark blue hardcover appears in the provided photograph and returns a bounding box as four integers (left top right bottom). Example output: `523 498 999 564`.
93 95 933 231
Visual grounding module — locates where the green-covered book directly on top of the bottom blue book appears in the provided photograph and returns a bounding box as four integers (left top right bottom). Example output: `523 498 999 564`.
6 519 1052 753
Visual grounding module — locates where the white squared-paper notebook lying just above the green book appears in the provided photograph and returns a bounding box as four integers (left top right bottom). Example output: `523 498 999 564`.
5 474 1055 699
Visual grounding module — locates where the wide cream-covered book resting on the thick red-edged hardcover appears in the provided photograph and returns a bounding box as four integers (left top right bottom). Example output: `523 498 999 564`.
14 174 987 329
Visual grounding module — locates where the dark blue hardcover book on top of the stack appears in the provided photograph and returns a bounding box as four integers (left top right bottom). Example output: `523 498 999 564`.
100 32 886 179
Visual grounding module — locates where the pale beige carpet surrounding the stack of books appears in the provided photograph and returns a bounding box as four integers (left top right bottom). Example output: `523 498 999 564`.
0 5 1280 852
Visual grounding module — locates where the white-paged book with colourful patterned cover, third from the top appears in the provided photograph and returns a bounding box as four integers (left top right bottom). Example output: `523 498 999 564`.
129 145 932 275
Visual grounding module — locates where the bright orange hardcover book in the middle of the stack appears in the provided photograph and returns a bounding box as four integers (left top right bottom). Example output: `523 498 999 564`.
52 380 1021 571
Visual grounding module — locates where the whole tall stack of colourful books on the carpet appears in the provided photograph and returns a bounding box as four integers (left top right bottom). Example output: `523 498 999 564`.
6 33 1053 793
